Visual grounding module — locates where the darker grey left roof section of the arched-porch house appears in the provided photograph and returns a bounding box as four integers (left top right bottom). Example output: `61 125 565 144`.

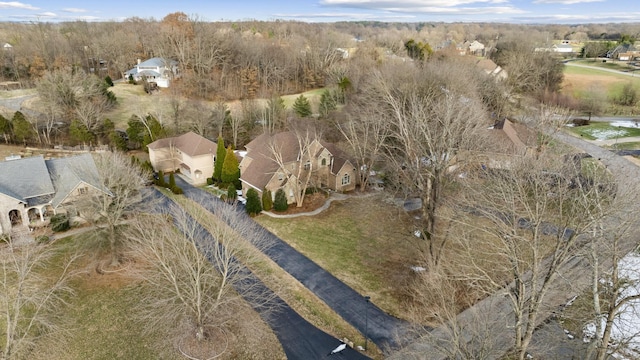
0 156 54 203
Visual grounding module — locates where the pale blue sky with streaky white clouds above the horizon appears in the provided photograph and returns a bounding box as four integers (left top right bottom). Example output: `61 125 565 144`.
0 0 640 24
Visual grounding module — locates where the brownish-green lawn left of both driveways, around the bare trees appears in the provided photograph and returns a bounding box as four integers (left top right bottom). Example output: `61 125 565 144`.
20 229 285 360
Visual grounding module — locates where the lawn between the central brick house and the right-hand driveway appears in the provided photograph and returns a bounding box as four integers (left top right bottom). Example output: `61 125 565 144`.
256 195 422 318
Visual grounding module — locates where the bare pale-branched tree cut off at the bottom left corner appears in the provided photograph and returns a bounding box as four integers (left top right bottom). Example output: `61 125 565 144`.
0 238 77 360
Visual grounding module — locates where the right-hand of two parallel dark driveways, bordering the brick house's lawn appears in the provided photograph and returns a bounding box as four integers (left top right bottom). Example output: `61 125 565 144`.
176 177 408 351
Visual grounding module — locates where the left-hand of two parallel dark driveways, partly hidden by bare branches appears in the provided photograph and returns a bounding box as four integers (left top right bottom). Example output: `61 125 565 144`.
149 188 369 360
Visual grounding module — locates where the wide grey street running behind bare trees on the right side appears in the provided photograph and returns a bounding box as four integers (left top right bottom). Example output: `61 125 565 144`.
389 133 640 360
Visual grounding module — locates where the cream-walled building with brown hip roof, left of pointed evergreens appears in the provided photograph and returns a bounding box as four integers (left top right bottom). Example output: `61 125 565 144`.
147 131 218 185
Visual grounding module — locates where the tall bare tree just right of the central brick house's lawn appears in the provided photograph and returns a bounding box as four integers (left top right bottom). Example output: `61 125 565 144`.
367 62 486 265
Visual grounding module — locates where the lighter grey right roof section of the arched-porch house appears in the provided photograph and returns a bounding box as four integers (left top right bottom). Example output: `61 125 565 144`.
46 153 109 207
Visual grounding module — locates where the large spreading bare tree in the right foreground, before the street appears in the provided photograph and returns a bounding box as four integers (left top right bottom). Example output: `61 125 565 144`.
450 151 613 359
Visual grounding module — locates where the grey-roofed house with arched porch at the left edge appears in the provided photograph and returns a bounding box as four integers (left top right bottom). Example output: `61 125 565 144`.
0 153 108 234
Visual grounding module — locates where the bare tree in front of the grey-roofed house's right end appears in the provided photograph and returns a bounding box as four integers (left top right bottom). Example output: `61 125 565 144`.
78 152 151 266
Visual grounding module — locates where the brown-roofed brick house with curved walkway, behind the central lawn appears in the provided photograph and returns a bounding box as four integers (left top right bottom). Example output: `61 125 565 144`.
240 131 358 204
